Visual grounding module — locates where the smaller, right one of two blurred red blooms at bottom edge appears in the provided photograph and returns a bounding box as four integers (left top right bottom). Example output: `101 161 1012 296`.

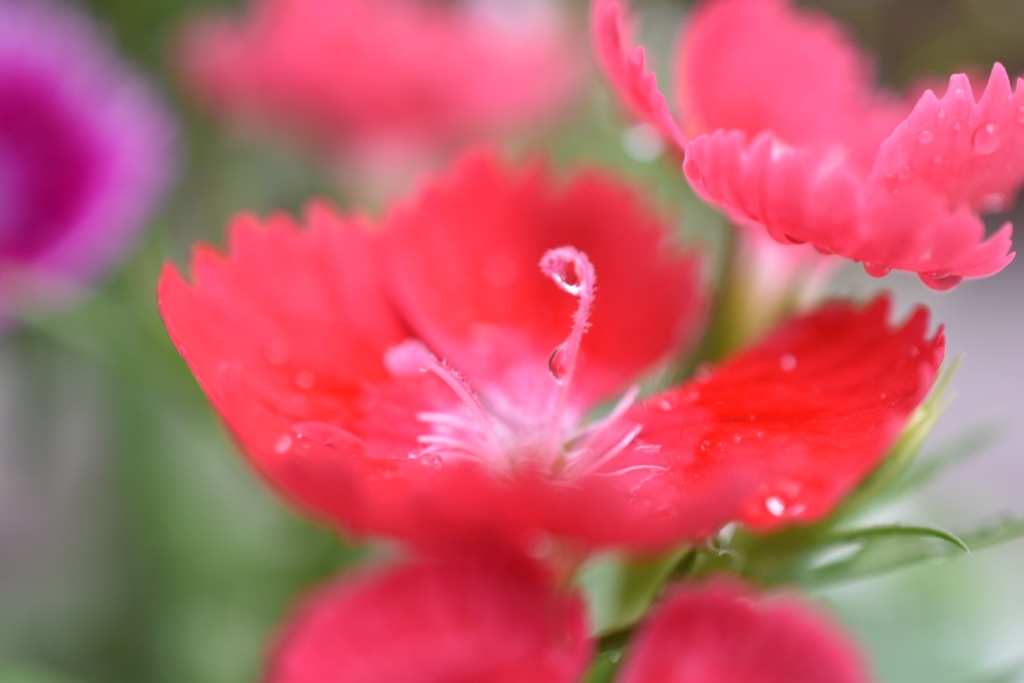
615 580 870 683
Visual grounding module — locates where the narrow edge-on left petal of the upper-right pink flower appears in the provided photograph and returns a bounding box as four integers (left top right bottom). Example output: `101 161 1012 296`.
591 0 686 152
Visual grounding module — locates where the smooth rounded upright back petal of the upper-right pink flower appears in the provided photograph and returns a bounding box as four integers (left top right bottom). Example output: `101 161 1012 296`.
676 0 884 160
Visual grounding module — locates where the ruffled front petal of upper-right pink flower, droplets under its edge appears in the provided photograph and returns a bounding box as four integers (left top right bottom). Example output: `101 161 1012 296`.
683 131 1013 289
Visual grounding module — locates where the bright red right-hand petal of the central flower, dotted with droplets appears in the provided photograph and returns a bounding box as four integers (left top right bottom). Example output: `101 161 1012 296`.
624 298 944 529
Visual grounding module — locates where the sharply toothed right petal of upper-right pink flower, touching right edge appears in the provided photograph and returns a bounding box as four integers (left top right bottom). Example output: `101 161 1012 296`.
871 63 1024 211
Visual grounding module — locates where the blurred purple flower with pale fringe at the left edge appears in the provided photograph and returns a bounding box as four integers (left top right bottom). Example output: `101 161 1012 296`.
0 0 174 308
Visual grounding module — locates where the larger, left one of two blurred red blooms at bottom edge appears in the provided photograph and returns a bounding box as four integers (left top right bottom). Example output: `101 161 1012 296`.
266 556 592 683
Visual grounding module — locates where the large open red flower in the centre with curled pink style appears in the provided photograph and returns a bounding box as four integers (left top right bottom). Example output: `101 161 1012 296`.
160 149 943 548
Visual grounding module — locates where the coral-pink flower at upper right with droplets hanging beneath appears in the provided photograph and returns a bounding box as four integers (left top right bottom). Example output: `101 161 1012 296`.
594 0 1024 289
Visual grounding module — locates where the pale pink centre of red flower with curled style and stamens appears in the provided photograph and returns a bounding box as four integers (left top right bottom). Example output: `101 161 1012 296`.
384 247 641 478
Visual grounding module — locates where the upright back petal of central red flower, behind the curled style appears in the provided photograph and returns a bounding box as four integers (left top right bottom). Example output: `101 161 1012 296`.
385 152 705 417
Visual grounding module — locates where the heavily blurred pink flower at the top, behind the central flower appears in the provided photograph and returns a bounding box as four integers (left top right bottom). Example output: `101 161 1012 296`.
179 0 585 163
